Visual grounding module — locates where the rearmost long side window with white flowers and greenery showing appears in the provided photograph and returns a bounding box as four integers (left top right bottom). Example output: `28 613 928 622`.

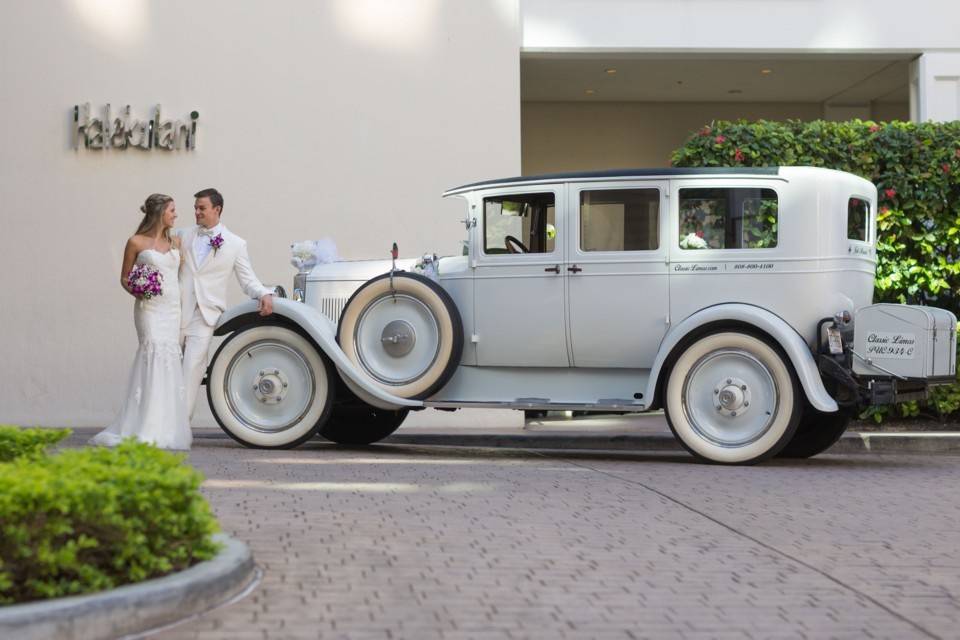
680 187 779 249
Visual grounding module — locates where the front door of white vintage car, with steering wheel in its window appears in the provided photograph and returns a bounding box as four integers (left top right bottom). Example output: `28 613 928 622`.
474 185 570 367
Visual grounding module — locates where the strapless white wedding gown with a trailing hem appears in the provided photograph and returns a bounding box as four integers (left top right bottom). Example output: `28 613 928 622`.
90 249 193 449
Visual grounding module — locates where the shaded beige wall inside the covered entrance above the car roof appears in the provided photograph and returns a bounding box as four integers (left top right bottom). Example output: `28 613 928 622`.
522 102 907 175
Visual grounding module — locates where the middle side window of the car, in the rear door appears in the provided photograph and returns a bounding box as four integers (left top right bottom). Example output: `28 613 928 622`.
580 189 660 251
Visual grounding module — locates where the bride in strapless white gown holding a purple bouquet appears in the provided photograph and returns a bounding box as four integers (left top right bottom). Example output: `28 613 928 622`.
90 193 192 449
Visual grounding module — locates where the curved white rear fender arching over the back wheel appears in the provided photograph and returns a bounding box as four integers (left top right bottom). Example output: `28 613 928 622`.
646 303 839 413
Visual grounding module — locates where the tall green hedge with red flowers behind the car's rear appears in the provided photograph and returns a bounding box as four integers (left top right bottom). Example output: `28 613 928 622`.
671 120 960 421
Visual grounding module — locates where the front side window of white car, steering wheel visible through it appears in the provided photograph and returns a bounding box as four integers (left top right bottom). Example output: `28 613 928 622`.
483 193 557 255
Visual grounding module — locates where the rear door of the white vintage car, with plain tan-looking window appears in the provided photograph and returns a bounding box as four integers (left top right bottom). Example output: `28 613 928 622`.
564 180 670 369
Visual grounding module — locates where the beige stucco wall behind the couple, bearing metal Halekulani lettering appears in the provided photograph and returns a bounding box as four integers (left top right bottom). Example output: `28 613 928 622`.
0 0 520 426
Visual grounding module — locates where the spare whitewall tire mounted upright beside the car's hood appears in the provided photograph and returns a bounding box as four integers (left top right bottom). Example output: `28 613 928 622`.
337 271 463 400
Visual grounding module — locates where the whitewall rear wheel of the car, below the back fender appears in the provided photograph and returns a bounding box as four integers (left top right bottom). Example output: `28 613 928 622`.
664 331 803 464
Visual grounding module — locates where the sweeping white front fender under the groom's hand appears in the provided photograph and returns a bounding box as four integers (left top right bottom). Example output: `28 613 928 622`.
213 297 423 409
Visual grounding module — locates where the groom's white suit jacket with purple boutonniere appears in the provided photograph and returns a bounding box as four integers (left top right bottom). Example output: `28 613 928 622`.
179 225 273 328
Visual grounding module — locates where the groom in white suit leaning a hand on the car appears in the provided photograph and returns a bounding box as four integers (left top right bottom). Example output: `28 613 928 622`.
180 189 273 419
